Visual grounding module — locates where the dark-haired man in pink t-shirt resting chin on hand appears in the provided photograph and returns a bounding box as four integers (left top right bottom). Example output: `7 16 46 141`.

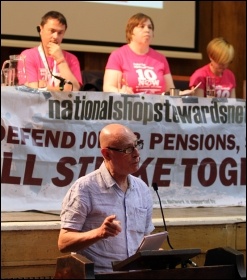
21 11 82 91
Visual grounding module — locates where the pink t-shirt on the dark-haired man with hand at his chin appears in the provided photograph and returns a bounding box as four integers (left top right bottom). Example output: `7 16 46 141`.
21 47 82 85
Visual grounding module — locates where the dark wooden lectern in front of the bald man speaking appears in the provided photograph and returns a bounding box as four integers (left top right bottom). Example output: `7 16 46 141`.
54 247 246 280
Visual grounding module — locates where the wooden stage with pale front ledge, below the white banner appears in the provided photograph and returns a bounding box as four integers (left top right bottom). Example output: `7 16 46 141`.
1 207 246 279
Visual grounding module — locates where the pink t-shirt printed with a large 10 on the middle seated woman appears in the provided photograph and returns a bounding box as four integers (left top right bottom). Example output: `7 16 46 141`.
106 45 170 94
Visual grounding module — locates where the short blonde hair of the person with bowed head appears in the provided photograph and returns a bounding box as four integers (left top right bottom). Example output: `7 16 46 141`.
207 37 234 64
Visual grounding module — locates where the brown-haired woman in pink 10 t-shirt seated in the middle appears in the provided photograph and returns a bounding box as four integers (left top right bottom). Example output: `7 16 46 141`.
103 13 174 94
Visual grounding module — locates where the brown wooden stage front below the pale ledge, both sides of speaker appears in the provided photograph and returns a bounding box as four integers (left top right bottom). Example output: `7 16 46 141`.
1 222 246 279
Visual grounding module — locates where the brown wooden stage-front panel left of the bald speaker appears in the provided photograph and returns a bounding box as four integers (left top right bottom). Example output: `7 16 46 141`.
1 230 64 279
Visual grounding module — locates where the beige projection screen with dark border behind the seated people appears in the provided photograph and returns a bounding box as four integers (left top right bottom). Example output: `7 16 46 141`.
1 1 198 58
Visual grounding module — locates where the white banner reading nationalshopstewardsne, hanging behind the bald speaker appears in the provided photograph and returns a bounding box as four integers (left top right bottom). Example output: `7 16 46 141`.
1 87 246 211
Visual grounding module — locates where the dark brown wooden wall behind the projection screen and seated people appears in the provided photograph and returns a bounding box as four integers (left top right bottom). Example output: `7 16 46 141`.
1 1 246 98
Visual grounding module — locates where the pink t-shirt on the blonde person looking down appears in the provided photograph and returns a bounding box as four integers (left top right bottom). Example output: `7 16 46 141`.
190 64 236 98
